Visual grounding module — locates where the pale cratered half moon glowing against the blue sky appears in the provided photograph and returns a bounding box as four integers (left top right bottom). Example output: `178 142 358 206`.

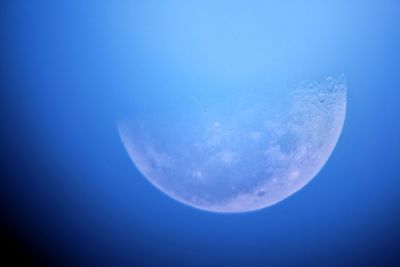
117 75 347 213
